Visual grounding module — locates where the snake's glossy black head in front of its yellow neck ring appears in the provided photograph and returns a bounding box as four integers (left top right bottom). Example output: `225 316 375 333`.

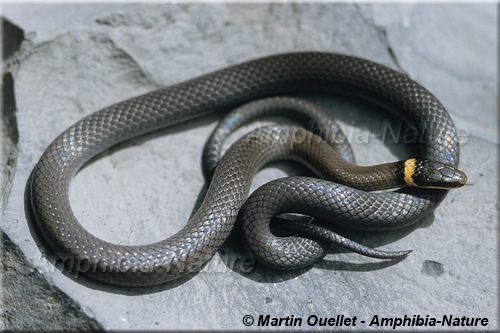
412 160 467 189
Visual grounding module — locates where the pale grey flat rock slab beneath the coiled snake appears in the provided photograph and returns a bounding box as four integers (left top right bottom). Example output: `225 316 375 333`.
0 3 498 330
